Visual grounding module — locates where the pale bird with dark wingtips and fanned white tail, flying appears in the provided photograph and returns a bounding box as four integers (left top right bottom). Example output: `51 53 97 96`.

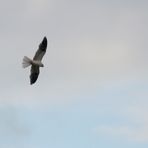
22 36 47 85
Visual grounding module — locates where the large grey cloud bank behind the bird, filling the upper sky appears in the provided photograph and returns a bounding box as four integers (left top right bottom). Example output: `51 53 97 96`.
0 0 148 107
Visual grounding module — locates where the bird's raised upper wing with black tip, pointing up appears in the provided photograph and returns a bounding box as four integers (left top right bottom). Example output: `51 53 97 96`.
33 37 47 61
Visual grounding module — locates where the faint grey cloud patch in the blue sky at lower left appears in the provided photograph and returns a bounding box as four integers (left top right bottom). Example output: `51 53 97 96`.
0 104 30 139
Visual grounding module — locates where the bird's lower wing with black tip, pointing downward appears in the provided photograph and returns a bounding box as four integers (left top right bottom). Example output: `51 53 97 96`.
30 65 40 85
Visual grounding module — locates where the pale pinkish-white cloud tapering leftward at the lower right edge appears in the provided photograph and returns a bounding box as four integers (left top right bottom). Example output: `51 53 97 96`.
93 105 148 143
